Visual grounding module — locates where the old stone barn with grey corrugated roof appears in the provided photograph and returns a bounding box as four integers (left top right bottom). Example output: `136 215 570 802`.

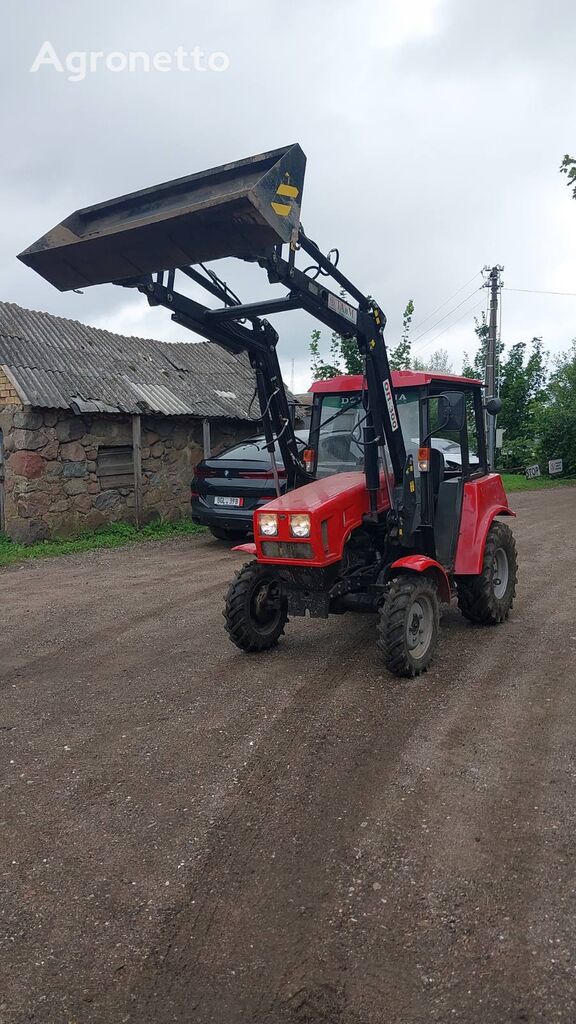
0 302 258 543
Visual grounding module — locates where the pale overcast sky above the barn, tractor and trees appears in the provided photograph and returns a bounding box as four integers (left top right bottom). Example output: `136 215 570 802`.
0 0 576 390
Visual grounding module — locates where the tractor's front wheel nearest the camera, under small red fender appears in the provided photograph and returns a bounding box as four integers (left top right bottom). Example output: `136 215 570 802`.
378 574 440 678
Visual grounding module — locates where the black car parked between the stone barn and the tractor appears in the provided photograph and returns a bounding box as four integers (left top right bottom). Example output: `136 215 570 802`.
191 430 307 541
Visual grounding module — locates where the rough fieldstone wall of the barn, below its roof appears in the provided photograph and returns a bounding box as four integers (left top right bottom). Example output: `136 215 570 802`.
0 407 254 543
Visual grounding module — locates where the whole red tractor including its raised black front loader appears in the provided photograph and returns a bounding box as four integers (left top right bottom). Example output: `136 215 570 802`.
19 145 517 676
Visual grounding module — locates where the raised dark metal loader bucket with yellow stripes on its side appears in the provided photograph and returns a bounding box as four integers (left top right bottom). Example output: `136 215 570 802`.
18 145 306 292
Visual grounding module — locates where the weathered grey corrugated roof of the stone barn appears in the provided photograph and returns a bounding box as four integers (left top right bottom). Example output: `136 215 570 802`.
0 302 258 420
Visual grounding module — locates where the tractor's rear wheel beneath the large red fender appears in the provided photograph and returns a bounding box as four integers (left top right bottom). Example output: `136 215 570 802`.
456 522 518 626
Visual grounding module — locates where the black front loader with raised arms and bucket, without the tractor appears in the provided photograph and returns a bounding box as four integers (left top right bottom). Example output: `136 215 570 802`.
18 145 403 512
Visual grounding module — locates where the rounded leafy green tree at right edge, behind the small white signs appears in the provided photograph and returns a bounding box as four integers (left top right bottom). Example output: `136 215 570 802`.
535 338 576 476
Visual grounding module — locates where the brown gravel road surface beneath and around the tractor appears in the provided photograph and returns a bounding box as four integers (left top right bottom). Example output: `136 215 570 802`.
0 489 576 1024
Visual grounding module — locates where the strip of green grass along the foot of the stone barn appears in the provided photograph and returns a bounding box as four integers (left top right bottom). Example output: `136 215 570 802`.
0 519 204 566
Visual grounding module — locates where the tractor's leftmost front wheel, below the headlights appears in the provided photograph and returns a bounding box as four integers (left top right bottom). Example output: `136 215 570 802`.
223 562 288 651
